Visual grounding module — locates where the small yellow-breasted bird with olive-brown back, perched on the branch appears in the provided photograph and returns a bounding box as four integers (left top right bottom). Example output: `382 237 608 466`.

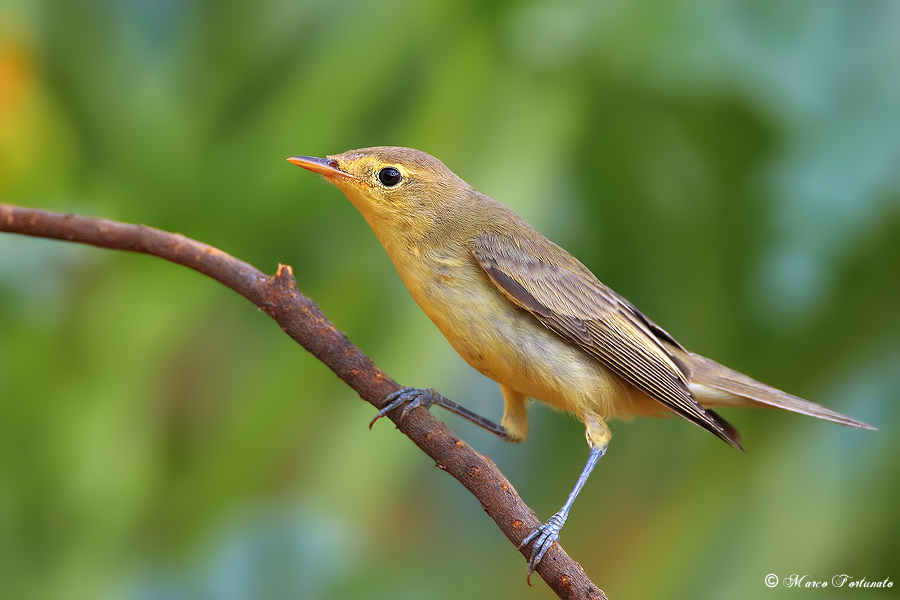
288 147 874 575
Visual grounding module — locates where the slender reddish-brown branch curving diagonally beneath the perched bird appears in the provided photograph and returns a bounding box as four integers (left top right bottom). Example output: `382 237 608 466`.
0 204 606 599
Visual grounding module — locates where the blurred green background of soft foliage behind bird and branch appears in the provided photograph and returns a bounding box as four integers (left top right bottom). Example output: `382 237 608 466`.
0 0 900 600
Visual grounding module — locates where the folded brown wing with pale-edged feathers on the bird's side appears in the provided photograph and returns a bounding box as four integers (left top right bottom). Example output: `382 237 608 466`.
469 233 740 448
